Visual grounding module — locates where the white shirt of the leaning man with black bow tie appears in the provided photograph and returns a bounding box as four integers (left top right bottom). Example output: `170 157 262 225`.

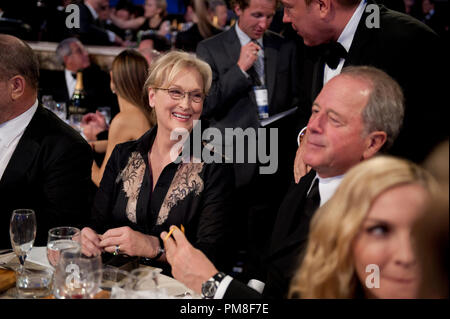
323 0 367 85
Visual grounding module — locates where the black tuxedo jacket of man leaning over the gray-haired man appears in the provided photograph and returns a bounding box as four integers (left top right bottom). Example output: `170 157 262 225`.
299 0 448 162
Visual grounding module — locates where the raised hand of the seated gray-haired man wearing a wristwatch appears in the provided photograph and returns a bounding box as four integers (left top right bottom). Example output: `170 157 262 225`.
161 226 219 294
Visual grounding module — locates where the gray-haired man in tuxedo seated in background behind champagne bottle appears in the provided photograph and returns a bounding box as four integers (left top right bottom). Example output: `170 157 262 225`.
40 38 118 116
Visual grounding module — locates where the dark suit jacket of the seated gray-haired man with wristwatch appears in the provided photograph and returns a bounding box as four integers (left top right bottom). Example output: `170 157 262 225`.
224 170 316 299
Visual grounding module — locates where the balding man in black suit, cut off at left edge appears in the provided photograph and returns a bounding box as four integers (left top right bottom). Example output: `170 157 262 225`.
0 35 92 248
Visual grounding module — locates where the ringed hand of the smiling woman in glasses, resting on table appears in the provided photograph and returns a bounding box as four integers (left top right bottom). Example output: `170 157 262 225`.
100 226 159 258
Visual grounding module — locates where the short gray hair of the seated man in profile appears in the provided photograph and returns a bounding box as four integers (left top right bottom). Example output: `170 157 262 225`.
341 66 405 152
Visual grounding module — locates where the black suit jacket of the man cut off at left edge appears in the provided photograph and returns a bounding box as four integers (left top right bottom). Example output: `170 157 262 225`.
0 106 93 248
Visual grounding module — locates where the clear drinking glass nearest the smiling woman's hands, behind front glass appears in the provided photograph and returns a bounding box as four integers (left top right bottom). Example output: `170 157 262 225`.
47 226 81 267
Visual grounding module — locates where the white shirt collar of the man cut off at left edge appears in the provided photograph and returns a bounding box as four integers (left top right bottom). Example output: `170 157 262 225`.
0 100 38 180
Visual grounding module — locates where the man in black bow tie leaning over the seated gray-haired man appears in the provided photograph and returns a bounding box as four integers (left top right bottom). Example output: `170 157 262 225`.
282 0 448 162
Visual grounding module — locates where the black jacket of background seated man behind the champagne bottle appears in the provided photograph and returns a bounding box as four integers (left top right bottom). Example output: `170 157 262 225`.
39 64 119 116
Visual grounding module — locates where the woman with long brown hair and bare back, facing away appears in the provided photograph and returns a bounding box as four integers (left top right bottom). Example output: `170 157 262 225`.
83 49 155 186
